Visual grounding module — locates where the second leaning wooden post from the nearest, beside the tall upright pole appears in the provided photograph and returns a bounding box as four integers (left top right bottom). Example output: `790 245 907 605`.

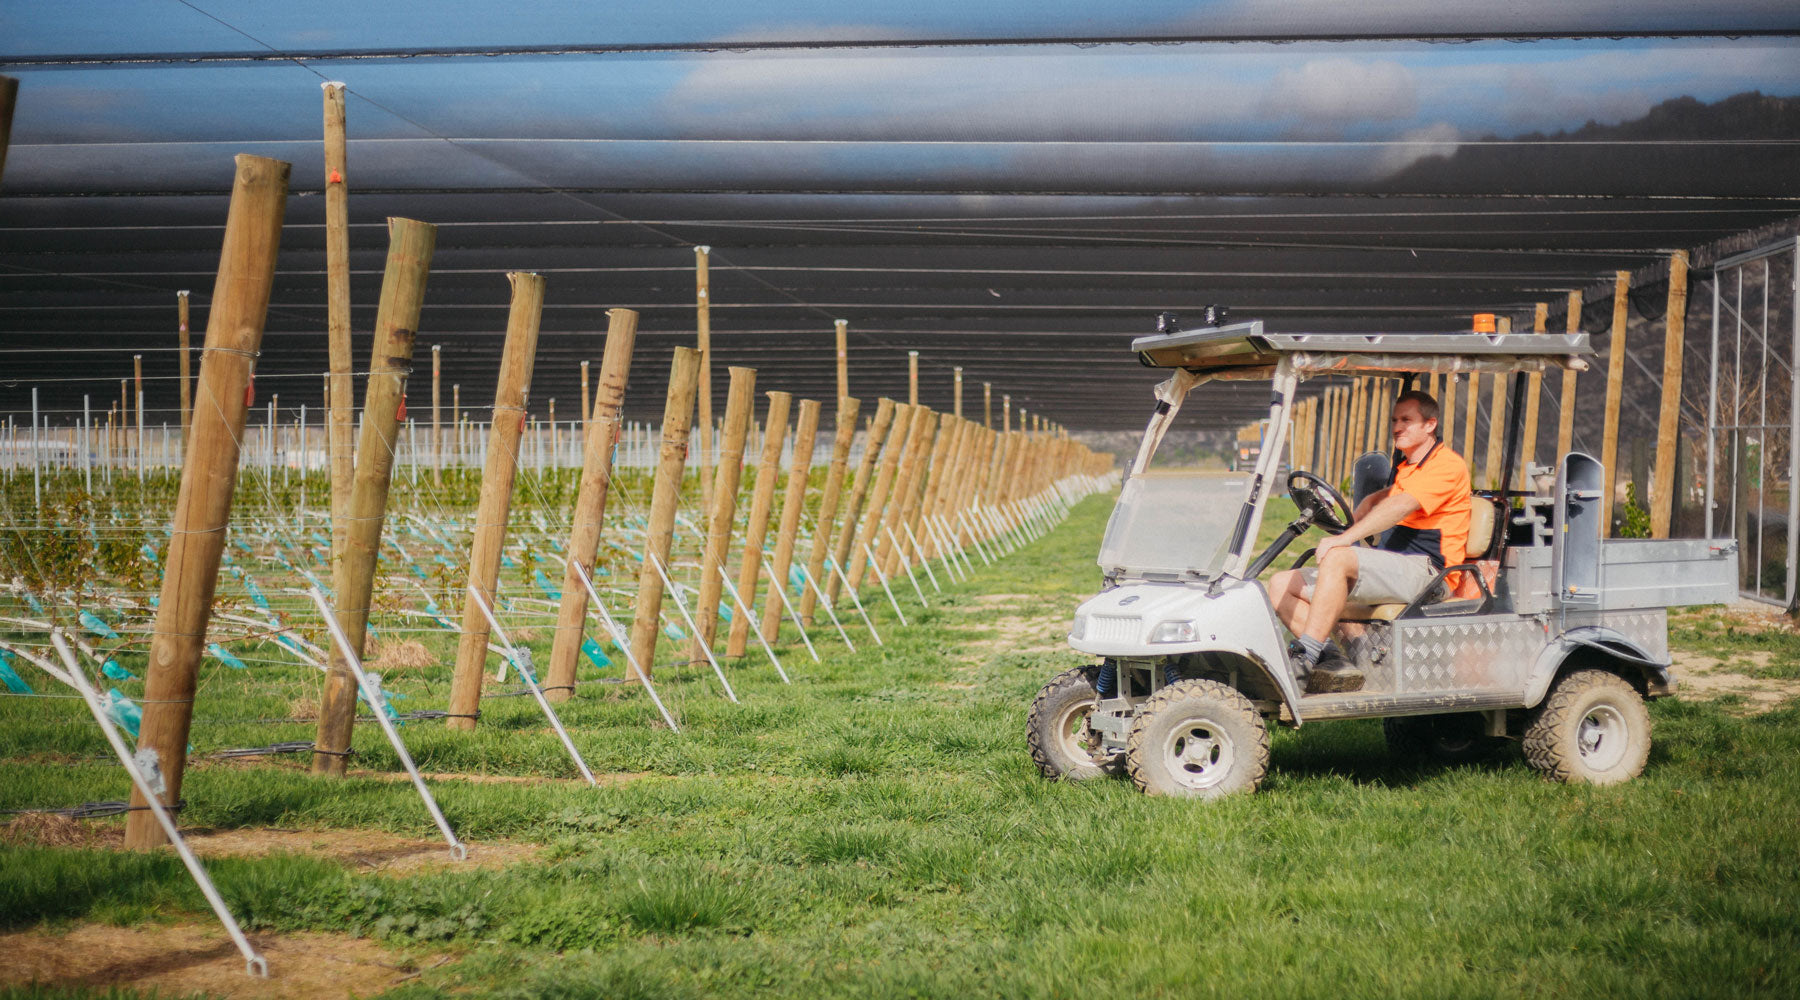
313 218 437 775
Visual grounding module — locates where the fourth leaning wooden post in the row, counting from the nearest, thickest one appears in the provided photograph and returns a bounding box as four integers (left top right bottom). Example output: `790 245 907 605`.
544 309 637 701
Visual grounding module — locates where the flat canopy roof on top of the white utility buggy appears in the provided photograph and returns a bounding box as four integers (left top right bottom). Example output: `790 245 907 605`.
1130 320 1593 379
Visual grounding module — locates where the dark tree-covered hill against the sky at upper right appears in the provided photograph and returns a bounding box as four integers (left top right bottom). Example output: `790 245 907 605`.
1373 92 1800 196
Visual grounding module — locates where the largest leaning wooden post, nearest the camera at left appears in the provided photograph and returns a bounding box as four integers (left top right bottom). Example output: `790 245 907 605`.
124 155 288 849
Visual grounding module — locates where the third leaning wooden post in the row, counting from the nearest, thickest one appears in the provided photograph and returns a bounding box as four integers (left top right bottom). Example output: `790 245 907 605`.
442 272 544 730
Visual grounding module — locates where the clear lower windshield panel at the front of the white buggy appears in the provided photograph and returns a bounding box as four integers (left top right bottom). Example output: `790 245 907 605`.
1100 468 1249 579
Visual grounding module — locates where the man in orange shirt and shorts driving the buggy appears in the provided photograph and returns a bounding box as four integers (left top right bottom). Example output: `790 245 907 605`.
1269 392 1472 692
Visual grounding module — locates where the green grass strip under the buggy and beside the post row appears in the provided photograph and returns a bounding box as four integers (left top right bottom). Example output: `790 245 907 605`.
0 498 1800 1000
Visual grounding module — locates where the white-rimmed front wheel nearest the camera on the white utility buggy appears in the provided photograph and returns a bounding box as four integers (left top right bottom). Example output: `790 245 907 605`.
1125 680 1269 799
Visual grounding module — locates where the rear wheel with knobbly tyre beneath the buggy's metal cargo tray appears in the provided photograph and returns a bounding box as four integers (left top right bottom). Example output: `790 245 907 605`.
1521 671 1651 784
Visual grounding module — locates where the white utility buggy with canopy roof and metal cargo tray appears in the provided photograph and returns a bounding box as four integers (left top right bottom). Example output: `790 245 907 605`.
1028 322 1737 797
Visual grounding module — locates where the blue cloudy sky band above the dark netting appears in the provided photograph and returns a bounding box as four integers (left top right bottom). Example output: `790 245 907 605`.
0 0 1800 191
